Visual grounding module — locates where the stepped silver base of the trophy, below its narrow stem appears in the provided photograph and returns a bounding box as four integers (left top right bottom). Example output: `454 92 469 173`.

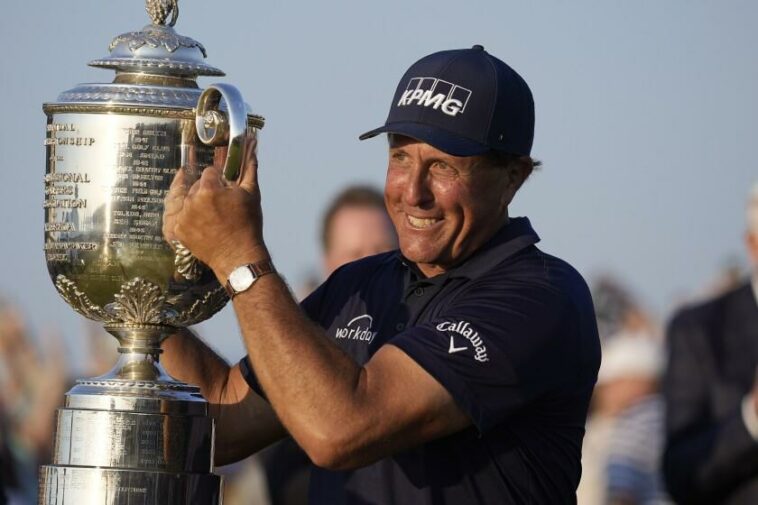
39 372 222 505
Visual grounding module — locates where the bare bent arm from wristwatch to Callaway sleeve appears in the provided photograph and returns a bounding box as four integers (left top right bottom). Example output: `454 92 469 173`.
226 268 471 469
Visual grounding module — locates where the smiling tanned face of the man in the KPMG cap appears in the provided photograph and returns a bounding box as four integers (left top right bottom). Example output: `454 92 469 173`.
384 135 516 277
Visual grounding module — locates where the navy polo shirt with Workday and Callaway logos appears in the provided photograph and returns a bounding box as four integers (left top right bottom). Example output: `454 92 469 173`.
241 218 600 505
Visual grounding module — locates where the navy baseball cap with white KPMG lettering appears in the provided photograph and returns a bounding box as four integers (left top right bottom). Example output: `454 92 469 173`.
359 45 534 156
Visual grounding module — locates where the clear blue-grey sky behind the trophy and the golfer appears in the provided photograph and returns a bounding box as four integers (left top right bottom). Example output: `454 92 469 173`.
0 0 758 368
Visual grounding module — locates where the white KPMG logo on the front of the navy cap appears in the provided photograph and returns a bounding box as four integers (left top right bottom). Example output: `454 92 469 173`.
397 77 471 117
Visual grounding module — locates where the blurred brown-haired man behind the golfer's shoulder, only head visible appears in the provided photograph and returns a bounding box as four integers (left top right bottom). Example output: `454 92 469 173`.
321 186 397 277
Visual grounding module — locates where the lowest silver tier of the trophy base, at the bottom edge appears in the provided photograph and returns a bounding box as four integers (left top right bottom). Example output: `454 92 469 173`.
38 465 222 505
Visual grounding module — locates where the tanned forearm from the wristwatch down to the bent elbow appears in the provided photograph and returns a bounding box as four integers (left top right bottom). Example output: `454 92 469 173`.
234 275 364 461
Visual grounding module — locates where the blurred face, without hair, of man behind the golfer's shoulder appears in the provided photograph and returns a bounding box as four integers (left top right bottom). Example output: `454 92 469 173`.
324 205 397 276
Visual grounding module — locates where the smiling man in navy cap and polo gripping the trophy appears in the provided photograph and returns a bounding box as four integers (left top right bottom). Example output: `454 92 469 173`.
165 46 599 504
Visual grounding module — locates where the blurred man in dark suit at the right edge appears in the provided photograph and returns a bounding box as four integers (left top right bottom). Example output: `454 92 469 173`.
664 185 758 505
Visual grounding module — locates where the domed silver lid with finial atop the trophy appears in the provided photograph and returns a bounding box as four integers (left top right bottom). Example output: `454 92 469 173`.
89 0 224 80
